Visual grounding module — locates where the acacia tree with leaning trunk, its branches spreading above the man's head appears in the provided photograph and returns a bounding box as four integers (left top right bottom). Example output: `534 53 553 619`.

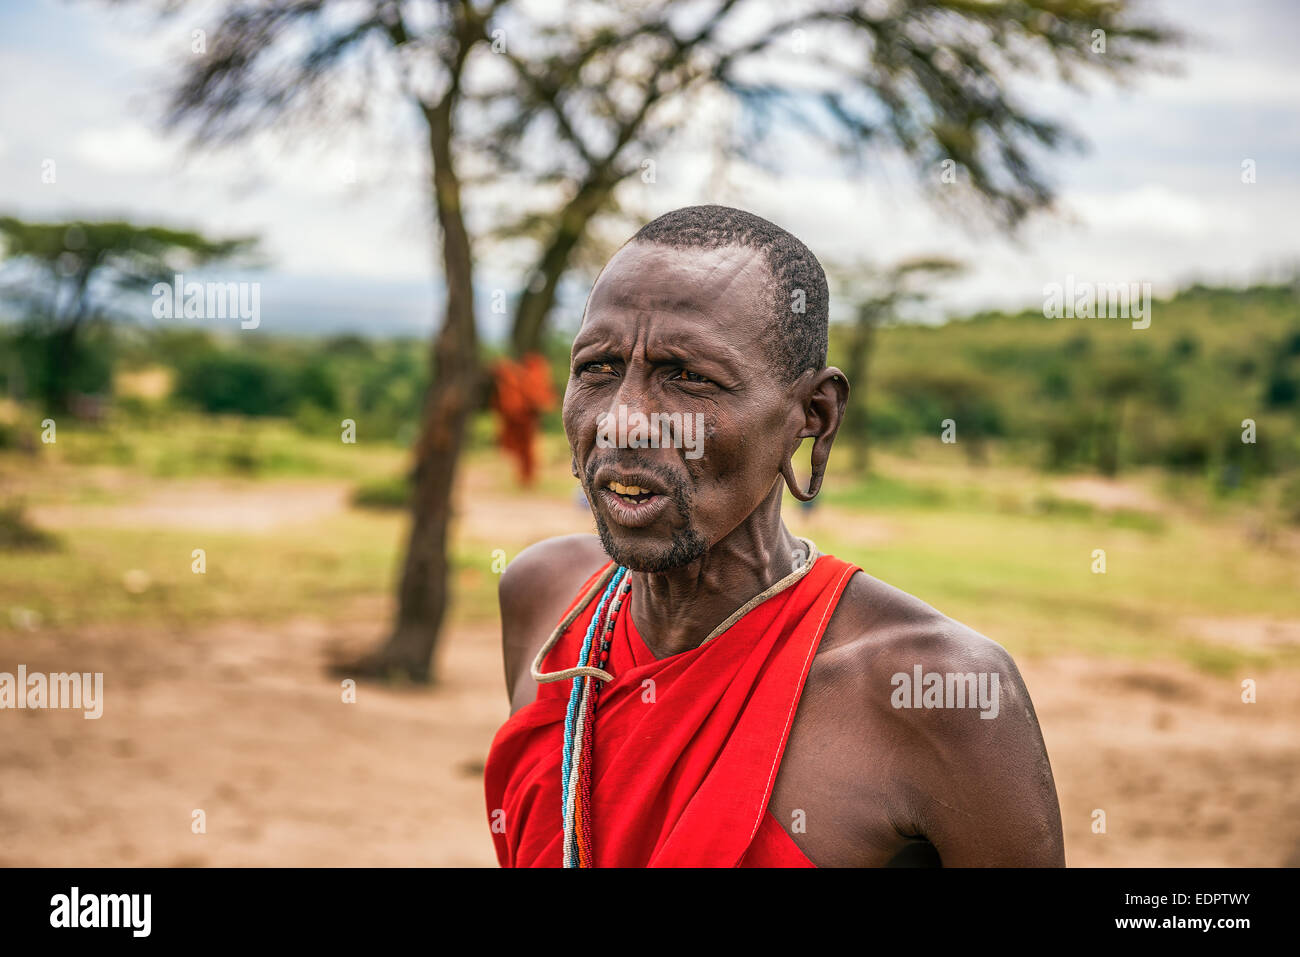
473 0 1177 352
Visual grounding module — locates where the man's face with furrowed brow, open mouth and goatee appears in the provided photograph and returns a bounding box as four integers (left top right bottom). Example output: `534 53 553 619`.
564 243 802 572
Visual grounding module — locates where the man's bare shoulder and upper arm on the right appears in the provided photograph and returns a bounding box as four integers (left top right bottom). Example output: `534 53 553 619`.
800 564 1065 866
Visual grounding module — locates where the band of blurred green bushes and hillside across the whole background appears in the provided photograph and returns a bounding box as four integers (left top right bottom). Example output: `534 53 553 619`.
0 274 1300 502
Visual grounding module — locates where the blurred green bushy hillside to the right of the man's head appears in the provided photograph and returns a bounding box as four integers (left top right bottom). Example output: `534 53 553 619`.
829 286 1300 478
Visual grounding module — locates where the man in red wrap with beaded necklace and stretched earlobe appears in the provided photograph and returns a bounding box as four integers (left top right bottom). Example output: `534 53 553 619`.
485 205 1063 866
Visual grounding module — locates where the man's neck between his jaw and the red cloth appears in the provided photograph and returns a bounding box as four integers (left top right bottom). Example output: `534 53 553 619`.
629 482 802 658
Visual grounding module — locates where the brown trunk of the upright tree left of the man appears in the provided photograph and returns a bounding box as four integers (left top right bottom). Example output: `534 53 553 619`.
359 92 481 683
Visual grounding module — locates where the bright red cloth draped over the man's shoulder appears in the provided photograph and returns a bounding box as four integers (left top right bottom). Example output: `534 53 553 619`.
484 555 858 867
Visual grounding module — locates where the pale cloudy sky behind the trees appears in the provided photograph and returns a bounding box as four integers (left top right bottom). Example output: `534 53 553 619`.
0 0 1300 332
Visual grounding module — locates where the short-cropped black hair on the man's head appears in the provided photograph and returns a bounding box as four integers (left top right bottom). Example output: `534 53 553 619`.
632 205 831 382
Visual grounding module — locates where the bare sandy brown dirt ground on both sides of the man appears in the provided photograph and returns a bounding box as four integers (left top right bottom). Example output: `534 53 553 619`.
0 601 1300 866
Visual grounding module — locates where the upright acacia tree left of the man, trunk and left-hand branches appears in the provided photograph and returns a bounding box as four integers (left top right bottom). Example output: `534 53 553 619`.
148 0 501 681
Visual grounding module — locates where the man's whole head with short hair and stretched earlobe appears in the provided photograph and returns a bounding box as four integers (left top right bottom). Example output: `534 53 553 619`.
564 205 848 572
